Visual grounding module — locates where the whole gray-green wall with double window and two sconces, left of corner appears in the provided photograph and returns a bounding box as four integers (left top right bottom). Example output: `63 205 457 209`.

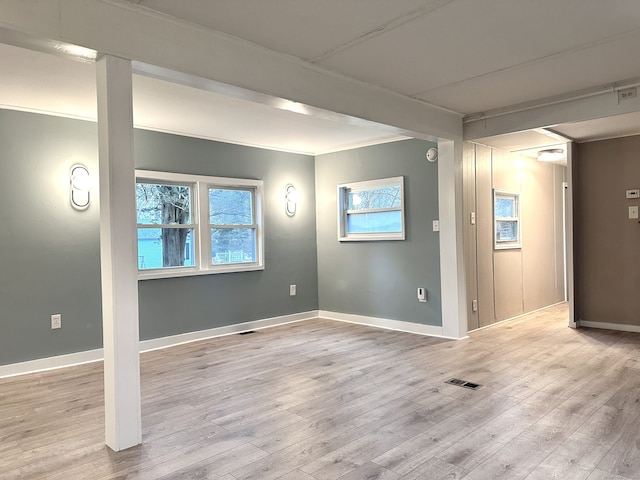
0 110 318 365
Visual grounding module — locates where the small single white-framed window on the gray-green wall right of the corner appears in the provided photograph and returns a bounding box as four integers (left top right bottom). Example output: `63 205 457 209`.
338 177 405 241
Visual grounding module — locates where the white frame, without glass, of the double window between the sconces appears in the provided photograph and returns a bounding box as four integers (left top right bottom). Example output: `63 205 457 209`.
135 170 264 280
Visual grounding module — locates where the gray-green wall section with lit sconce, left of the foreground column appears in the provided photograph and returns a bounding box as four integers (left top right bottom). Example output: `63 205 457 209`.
0 110 102 365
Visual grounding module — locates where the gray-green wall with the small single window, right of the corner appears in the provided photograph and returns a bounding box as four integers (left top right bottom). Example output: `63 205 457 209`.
316 140 442 326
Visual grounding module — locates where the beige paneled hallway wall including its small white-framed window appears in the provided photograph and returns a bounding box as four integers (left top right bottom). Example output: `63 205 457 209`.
463 142 569 331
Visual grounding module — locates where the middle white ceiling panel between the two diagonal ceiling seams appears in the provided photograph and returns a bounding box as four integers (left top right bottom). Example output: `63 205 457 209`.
320 0 640 99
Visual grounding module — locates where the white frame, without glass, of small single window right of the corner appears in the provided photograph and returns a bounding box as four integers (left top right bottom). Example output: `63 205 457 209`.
338 176 405 242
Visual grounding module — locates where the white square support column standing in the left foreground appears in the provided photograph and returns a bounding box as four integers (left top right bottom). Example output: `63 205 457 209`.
96 56 142 451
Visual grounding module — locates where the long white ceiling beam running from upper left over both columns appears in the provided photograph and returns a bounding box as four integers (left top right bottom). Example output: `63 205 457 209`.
0 0 462 140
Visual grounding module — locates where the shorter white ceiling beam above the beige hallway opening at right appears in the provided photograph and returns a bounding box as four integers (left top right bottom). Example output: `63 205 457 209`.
464 87 640 140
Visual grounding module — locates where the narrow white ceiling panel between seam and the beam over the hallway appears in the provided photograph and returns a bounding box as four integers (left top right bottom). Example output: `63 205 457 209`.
417 30 640 114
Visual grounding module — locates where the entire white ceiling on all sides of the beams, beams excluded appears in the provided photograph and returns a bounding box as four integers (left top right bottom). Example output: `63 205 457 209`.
0 0 640 154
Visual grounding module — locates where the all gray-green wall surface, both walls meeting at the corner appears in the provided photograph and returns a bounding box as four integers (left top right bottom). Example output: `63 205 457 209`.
0 110 442 365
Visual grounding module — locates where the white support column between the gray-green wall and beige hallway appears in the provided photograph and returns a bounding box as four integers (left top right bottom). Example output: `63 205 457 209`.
438 140 468 338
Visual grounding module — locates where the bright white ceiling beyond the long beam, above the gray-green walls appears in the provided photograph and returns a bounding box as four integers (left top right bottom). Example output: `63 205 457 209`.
0 43 406 155
